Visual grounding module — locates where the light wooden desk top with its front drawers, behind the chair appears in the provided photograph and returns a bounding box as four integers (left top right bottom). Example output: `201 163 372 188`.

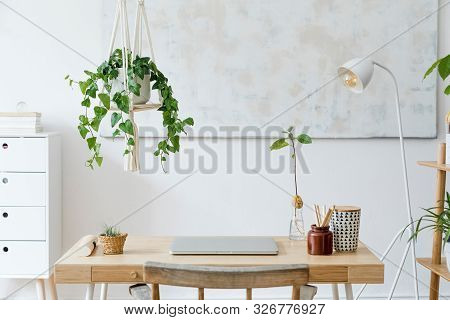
55 236 384 284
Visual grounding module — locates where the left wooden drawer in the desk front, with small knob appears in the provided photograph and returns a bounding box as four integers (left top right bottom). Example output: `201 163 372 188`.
92 266 144 283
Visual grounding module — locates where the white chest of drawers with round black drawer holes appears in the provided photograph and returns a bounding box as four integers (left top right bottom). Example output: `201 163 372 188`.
0 133 62 298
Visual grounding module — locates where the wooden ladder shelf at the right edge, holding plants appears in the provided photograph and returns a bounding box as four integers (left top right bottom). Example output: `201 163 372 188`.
417 143 450 300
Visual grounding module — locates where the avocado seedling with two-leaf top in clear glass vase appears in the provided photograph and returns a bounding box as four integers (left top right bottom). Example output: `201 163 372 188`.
270 127 312 240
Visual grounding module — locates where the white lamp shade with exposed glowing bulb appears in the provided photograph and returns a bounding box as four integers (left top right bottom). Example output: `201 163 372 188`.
338 58 374 93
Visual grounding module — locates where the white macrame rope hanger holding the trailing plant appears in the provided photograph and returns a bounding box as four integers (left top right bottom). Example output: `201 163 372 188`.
108 0 162 172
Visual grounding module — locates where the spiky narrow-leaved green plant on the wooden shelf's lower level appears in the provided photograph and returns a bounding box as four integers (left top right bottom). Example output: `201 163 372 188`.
402 192 450 245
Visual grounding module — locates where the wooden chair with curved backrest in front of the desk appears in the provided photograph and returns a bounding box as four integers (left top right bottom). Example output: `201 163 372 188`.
144 261 308 300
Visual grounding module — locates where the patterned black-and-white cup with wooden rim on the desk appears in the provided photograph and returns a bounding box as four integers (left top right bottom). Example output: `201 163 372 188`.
330 206 361 251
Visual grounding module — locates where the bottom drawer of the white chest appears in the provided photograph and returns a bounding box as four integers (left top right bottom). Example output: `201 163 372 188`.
0 241 49 275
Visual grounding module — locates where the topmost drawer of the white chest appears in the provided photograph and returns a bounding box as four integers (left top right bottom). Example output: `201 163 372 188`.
0 138 47 172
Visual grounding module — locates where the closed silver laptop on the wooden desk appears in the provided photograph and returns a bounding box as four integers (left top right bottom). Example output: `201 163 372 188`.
170 237 278 255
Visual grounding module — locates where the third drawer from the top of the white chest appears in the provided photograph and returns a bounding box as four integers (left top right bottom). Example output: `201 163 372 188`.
0 207 46 241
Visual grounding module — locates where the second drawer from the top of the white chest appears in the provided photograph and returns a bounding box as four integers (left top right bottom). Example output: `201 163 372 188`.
0 172 47 207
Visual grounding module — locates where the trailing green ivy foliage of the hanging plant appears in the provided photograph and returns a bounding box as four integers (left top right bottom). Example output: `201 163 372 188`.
65 49 194 169
